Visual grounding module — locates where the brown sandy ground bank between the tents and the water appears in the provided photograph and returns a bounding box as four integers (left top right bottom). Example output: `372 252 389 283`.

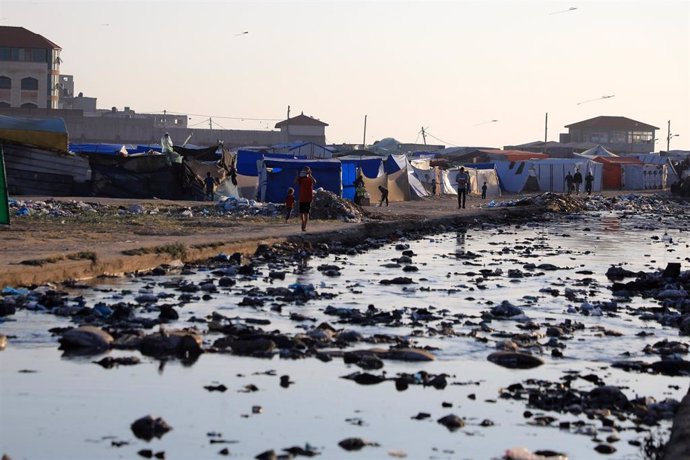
0 192 505 287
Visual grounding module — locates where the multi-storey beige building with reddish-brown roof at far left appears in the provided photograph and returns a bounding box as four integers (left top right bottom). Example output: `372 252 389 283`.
0 26 61 109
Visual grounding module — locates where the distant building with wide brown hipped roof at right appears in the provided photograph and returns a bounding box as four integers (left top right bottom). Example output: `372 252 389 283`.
560 116 659 153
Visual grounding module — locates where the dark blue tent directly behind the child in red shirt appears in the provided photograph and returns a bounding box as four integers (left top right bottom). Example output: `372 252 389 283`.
259 158 342 203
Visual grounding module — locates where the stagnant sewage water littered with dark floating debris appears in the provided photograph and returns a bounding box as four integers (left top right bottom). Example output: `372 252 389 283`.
0 209 690 460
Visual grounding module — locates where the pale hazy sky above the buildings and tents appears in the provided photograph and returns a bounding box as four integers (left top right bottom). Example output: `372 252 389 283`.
0 0 690 147
